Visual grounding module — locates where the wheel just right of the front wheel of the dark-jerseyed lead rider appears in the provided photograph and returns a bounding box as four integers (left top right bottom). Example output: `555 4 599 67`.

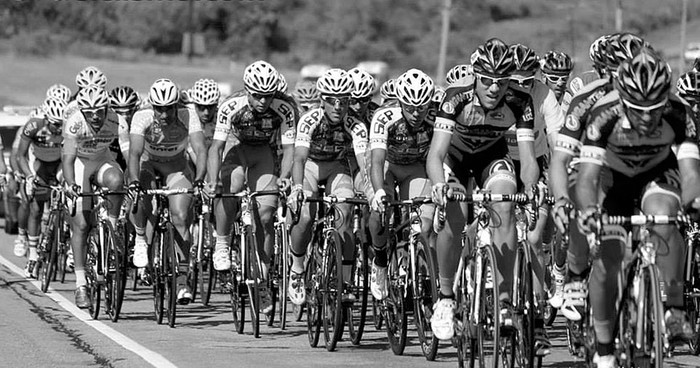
513 242 536 367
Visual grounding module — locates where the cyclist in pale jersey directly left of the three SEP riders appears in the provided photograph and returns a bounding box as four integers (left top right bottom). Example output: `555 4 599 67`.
128 79 207 304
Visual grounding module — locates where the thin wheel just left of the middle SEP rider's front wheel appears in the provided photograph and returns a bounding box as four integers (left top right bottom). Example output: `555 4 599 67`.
306 237 323 348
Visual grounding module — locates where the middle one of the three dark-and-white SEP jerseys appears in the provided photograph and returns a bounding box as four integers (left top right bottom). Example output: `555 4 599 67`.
294 108 368 161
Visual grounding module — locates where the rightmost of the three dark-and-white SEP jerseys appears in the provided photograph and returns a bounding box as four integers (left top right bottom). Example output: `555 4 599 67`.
369 104 437 165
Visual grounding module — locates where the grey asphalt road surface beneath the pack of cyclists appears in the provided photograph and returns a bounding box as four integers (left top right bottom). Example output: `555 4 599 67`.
0 218 700 368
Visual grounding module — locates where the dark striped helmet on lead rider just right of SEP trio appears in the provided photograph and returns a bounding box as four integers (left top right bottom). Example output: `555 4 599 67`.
471 38 515 77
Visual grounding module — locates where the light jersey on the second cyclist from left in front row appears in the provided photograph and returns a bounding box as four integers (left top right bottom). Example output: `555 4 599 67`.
63 109 129 159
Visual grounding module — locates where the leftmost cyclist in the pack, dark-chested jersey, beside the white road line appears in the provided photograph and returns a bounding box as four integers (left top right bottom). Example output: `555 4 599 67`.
17 97 66 278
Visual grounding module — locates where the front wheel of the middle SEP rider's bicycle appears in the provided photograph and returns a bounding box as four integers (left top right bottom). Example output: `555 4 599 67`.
321 230 344 351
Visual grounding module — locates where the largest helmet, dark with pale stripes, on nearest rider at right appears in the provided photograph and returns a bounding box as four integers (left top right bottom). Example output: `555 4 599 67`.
614 48 671 106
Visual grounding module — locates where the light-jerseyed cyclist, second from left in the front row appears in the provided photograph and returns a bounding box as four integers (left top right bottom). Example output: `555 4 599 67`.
61 85 128 308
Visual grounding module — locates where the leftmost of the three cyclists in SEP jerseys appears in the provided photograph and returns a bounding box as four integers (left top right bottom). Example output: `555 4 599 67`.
207 60 297 313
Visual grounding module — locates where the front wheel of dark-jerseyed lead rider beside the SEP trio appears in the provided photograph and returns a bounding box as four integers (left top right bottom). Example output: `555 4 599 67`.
469 245 500 368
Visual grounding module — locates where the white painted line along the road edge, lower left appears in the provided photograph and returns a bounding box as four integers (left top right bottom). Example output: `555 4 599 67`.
0 256 177 368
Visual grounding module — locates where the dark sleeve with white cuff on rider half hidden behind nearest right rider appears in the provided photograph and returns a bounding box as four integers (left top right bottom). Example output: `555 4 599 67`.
554 79 613 157
